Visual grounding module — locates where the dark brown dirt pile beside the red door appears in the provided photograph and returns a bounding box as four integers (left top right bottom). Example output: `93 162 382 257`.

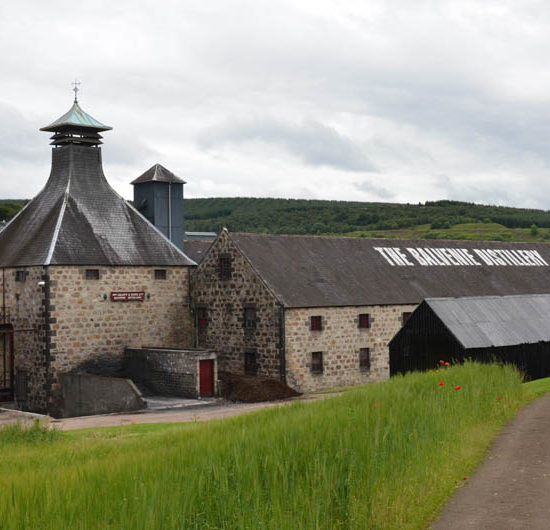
218 372 301 403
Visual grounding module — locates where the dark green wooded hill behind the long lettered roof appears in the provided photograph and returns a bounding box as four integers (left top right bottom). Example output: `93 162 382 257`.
184 198 550 235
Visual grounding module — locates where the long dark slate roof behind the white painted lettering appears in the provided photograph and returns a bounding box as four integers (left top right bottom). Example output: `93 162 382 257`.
229 233 550 307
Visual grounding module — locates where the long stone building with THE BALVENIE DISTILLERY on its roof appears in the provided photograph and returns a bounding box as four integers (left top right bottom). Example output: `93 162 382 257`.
192 230 550 391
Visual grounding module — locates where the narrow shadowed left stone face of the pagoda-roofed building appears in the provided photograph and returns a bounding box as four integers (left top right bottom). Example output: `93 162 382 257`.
0 267 48 412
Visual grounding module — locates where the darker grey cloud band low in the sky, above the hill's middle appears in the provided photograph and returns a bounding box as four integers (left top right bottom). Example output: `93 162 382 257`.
199 119 376 172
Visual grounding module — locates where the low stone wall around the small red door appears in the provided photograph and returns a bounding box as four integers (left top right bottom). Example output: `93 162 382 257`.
124 348 218 398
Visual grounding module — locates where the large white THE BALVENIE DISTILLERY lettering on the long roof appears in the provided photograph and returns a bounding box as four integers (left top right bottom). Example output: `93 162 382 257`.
374 247 549 267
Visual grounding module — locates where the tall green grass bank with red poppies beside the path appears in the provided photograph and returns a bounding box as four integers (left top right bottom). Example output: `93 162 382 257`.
0 364 548 529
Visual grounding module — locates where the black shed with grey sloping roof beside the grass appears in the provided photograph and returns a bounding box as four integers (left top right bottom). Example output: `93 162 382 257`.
390 294 550 379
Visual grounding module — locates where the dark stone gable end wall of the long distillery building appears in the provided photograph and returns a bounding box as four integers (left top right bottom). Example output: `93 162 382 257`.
192 231 281 379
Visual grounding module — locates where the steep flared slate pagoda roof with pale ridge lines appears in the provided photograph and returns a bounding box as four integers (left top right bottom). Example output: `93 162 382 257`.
0 106 196 267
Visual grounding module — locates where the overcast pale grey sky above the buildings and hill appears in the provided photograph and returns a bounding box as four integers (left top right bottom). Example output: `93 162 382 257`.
0 0 550 209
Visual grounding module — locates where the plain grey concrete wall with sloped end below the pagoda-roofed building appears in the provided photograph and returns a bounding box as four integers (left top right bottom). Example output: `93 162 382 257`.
56 374 145 418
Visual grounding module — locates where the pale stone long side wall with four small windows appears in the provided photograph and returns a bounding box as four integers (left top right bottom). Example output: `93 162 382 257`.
285 305 416 392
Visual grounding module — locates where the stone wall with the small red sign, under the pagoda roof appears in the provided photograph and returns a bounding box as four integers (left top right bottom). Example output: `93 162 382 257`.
48 266 193 412
